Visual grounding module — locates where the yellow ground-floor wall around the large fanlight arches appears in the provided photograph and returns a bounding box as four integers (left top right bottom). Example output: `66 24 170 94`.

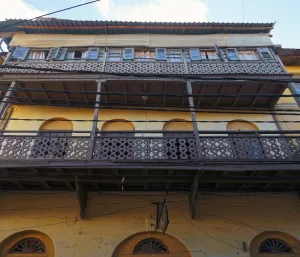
0 192 300 257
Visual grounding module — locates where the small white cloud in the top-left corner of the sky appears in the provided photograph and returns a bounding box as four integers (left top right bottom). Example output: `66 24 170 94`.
0 0 45 20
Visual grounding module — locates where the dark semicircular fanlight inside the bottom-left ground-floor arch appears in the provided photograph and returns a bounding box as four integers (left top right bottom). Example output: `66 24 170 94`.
9 238 46 254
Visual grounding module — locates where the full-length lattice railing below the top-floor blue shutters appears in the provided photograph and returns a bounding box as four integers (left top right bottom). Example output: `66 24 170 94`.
0 61 286 74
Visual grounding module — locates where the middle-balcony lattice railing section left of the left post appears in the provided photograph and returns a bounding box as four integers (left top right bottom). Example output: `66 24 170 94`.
0 136 89 160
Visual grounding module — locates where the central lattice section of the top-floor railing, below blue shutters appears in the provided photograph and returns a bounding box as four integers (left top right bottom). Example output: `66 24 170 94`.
105 62 186 74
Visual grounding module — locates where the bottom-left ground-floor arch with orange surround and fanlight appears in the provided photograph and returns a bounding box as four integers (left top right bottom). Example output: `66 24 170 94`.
0 230 55 257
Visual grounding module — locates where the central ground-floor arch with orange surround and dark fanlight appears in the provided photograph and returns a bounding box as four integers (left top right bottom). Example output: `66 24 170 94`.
112 232 191 257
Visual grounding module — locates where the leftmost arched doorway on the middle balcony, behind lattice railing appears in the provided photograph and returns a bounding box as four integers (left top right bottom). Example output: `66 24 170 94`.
32 118 73 159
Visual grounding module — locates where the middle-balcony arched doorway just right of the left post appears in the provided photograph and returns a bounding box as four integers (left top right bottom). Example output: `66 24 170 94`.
100 119 135 160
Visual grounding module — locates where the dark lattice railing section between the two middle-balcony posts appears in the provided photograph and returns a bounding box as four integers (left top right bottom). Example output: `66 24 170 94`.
93 138 197 160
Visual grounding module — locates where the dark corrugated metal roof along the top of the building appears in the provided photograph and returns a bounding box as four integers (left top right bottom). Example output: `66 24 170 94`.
0 18 274 35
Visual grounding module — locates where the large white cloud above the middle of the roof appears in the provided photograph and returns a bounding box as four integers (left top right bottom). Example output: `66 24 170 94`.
96 0 208 22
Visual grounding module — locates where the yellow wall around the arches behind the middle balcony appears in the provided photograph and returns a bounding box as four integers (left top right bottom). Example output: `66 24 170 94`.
6 105 277 134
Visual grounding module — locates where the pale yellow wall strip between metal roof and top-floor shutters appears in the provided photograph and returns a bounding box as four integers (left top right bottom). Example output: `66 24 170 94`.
10 34 273 47
